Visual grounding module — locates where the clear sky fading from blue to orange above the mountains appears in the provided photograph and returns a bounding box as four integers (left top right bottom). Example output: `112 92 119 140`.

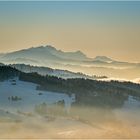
0 1 140 62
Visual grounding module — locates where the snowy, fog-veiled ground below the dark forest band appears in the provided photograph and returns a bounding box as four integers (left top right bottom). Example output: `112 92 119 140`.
0 80 140 138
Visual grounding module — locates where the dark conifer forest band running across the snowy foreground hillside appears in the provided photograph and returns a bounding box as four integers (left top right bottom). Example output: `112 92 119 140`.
0 66 140 107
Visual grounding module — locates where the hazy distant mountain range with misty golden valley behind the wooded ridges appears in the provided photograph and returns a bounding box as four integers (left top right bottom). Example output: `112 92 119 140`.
0 45 140 79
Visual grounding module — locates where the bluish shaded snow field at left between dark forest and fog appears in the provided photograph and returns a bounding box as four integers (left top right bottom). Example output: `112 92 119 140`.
0 78 75 111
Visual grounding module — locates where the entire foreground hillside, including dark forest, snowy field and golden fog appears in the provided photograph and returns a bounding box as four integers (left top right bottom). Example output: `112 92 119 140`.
0 66 140 139
